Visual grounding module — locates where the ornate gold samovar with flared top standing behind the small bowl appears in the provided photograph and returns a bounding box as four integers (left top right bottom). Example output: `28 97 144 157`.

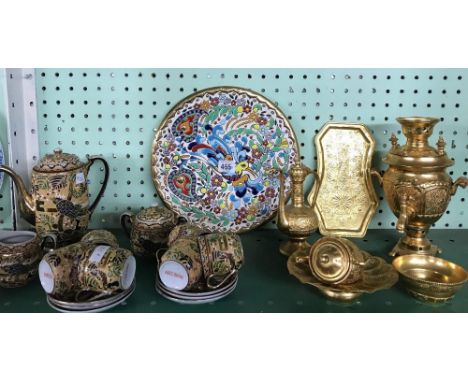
383 117 468 256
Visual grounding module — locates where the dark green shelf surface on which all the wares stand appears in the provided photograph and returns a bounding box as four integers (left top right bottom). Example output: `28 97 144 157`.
0 229 468 313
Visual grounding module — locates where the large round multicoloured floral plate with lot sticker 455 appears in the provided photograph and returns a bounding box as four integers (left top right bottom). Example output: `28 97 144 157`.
152 87 299 232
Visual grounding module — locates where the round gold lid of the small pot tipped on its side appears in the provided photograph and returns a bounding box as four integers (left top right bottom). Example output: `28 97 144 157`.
309 237 352 284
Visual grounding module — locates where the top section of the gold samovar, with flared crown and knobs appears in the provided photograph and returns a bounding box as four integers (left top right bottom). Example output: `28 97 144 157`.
383 117 454 170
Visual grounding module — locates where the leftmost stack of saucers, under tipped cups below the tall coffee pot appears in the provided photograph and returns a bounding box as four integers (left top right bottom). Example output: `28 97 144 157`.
47 280 136 313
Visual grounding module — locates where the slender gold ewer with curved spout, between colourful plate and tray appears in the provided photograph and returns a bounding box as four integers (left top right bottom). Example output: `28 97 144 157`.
277 162 317 256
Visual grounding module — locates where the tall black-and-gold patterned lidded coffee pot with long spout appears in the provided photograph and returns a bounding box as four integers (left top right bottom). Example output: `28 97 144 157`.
0 149 109 243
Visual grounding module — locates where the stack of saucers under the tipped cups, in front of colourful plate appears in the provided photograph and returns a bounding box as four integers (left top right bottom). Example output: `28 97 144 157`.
156 274 237 304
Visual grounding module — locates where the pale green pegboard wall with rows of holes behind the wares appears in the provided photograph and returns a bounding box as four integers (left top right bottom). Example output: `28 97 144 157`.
36 69 468 228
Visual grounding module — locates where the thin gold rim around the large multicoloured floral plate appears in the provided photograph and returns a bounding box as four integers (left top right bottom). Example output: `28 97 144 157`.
150 85 301 234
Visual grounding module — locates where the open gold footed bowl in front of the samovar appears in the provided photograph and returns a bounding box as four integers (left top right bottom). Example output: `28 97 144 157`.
392 255 468 303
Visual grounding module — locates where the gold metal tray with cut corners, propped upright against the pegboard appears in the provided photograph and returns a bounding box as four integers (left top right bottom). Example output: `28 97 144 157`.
308 122 378 237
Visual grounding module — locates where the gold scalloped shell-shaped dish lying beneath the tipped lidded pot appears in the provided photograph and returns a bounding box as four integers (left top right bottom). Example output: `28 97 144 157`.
288 250 398 301
